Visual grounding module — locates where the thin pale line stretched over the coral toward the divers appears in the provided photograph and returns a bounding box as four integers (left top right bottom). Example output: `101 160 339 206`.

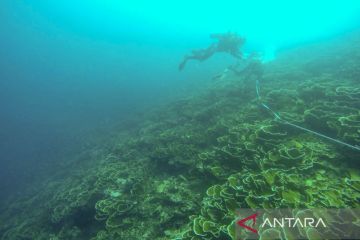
256 80 360 151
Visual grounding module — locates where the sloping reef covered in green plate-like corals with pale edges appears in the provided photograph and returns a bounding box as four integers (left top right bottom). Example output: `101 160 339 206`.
0 34 360 240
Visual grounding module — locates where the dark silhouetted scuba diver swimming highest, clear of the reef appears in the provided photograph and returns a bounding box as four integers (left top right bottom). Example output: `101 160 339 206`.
179 32 245 71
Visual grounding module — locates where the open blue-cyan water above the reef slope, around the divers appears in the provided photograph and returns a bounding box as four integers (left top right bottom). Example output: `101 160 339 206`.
0 0 360 199
